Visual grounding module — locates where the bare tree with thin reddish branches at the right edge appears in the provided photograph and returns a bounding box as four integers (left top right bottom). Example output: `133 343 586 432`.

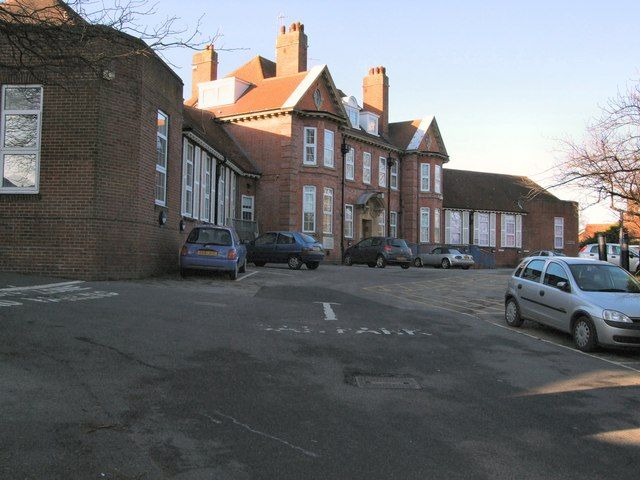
553 84 640 226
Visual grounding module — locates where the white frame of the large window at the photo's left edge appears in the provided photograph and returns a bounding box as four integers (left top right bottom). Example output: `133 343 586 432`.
0 85 44 194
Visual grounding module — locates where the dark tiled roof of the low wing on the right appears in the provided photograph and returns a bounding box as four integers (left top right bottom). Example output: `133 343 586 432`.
442 168 562 212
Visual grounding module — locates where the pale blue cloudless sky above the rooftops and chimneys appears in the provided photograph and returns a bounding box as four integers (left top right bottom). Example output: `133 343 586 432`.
151 0 640 225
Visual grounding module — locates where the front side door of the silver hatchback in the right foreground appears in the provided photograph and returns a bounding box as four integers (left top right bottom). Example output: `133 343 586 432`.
538 262 574 332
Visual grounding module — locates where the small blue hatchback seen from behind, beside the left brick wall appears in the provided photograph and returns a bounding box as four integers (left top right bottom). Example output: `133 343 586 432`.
180 226 247 280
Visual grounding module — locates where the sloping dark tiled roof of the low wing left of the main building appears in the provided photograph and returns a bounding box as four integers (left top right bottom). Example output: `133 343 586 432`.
183 105 260 174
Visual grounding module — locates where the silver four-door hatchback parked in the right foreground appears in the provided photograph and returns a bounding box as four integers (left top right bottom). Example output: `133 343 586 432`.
505 257 640 352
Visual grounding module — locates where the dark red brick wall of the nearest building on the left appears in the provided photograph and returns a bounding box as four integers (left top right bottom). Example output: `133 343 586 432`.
0 45 182 279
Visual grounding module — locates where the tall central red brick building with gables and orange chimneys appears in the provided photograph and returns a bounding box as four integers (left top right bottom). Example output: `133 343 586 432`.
187 23 448 260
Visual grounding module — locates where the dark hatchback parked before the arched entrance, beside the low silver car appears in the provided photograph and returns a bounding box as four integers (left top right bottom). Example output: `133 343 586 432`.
342 237 413 269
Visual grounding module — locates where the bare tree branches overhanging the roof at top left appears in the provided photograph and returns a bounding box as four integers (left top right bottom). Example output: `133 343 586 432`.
0 0 216 79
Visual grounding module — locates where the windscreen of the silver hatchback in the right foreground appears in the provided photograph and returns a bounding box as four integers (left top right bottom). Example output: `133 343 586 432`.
569 264 640 293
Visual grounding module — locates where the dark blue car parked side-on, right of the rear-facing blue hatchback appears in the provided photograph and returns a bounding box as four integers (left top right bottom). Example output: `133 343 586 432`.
247 232 324 270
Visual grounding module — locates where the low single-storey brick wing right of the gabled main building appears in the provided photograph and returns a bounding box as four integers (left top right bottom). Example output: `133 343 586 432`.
443 169 578 267
